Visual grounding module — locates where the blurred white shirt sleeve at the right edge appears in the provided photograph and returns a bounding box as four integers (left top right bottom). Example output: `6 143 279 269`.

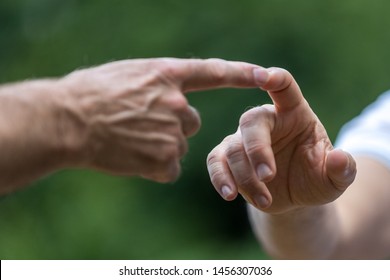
335 90 390 168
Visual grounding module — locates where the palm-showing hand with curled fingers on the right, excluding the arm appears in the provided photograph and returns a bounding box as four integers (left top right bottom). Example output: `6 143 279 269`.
207 68 356 213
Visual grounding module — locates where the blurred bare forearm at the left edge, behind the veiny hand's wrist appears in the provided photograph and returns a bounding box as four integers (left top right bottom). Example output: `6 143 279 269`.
0 80 80 194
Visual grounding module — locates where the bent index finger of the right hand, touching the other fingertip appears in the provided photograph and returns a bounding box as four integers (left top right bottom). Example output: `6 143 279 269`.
254 67 305 111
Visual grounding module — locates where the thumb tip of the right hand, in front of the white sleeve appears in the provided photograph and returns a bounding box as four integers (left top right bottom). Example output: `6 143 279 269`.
326 149 356 191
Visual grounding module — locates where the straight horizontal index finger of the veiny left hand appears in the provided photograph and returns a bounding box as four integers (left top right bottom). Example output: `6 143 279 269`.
161 58 259 92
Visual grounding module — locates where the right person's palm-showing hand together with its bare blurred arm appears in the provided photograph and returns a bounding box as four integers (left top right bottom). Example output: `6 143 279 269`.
207 68 390 259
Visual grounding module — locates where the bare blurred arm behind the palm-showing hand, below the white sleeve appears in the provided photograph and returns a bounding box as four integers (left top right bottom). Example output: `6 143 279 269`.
248 157 390 259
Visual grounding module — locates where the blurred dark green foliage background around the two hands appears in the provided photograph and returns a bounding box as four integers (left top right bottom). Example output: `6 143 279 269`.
0 0 390 259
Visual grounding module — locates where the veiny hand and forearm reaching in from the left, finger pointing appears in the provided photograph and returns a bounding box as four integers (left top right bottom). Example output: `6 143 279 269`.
0 58 258 194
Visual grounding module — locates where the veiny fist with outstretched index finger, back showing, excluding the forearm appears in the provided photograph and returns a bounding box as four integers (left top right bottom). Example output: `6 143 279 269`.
61 58 257 182
